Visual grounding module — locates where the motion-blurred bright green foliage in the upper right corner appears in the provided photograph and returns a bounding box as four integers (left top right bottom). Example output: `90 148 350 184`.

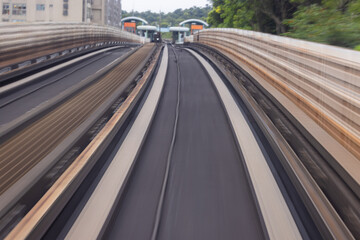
284 0 360 48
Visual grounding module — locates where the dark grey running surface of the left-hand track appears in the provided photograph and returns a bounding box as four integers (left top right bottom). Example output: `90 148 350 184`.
0 48 130 125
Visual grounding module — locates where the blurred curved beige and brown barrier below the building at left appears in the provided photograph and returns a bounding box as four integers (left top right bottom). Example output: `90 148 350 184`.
0 23 147 75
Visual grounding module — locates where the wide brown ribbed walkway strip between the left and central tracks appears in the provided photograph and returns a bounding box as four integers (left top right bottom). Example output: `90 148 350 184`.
0 45 153 194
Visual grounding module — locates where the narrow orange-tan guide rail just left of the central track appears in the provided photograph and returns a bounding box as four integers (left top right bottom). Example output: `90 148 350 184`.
5 45 167 240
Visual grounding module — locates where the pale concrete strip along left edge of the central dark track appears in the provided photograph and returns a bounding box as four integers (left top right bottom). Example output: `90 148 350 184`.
66 47 168 240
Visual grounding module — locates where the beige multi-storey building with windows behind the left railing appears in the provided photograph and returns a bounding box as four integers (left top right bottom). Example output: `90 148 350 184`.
0 0 121 27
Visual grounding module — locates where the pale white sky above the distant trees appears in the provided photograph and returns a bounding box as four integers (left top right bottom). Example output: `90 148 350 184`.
121 0 210 13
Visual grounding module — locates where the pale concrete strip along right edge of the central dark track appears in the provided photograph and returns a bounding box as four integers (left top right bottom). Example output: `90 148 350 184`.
187 49 302 239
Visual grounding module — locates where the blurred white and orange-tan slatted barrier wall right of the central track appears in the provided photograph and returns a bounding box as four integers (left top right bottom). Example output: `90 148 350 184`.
189 29 360 159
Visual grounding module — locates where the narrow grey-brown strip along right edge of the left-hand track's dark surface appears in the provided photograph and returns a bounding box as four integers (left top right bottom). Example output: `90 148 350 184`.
0 48 138 142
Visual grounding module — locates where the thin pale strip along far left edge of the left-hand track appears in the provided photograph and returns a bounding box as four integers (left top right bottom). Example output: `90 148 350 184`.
0 46 120 95
